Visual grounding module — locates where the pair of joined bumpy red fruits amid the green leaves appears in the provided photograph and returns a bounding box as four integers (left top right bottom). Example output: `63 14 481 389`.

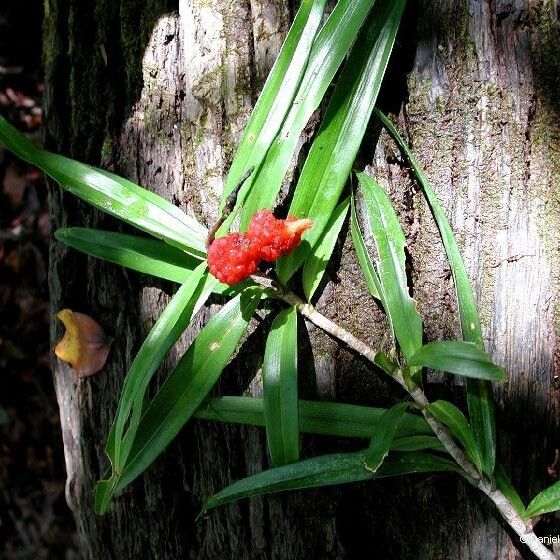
208 210 313 286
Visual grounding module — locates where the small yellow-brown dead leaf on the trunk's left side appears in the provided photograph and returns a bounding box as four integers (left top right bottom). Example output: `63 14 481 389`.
54 309 111 377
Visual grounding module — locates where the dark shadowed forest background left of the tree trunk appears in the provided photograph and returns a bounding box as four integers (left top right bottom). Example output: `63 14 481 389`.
0 0 77 560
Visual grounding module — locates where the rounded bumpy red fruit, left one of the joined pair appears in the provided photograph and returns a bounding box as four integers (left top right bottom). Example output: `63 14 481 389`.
208 233 259 286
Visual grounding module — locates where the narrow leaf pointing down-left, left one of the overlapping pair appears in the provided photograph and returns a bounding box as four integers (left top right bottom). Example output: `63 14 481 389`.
107 263 217 472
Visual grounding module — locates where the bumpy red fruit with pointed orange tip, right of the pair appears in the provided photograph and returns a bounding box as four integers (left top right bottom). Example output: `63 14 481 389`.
247 210 313 262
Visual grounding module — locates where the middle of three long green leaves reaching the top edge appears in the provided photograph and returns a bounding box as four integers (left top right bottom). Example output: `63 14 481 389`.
234 0 374 229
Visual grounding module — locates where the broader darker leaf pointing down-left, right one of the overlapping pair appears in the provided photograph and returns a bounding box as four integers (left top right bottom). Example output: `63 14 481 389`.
95 288 262 513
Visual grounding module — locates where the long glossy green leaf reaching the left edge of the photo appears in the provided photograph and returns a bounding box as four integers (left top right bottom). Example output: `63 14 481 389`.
0 117 207 258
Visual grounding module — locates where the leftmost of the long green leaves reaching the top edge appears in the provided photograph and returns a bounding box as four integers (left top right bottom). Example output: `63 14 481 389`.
220 0 326 209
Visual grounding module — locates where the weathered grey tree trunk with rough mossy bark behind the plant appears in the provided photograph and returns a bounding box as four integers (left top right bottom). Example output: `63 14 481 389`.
44 0 560 560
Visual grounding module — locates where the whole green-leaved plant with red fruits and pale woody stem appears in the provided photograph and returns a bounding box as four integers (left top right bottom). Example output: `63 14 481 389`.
0 0 560 559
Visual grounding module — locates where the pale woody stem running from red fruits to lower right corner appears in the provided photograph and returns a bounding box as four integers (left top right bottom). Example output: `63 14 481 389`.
264 280 555 560
